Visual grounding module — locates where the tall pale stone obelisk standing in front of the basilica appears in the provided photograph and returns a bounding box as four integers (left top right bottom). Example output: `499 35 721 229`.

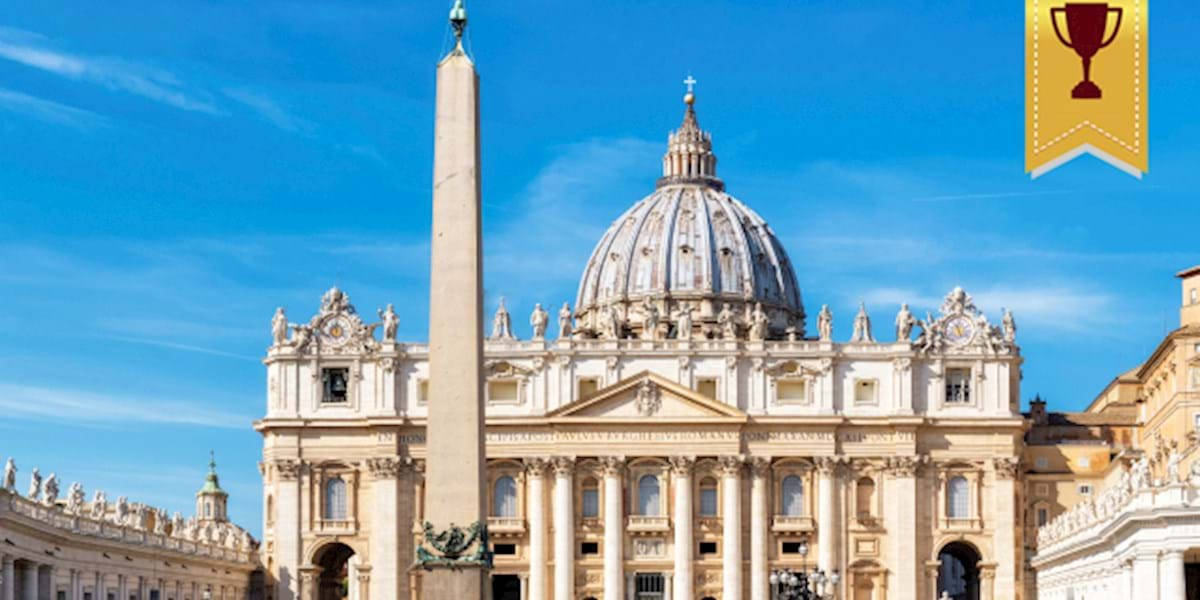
421 0 491 600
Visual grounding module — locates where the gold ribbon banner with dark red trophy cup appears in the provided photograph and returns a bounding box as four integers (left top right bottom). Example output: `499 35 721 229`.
1025 0 1150 179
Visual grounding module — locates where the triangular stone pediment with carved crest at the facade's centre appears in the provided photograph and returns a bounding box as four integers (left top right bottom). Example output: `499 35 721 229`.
547 371 746 421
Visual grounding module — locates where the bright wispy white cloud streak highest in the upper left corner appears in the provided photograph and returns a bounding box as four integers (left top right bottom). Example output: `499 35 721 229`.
0 29 221 114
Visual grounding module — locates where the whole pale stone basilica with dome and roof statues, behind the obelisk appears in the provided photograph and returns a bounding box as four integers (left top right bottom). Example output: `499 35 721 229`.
256 94 1027 600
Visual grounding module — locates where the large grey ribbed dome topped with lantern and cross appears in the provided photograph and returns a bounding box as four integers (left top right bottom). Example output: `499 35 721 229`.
576 94 804 338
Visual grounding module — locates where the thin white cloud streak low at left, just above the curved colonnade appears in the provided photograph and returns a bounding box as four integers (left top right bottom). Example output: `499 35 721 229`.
0 384 252 430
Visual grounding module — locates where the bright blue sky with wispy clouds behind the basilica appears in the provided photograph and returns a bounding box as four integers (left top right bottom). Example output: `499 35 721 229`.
0 0 1200 532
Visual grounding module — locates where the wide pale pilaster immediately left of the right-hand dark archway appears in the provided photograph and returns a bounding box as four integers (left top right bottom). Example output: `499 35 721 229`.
888 456 921 600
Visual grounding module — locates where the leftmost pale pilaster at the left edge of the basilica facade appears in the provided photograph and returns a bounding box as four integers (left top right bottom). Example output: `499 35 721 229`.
272 458 302 600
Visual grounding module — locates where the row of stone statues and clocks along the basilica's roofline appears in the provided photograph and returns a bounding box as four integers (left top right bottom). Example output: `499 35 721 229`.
271 287 1016 354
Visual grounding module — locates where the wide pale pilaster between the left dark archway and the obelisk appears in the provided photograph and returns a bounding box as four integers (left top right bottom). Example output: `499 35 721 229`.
364 456 409 600
